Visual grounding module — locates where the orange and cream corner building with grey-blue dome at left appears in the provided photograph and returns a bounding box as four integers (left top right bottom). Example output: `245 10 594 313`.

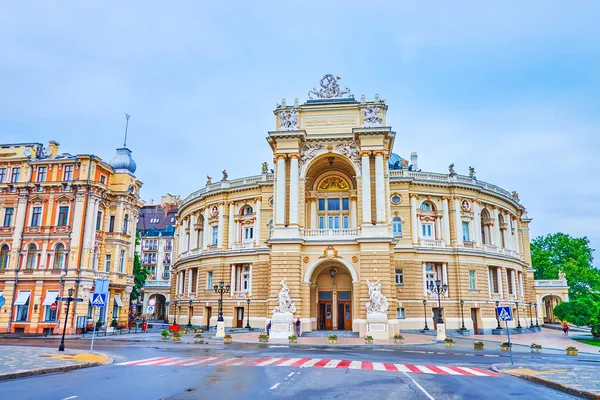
0 141 142 333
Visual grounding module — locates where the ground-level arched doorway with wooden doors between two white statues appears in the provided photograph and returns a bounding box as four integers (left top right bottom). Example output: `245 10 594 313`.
310 260 354 330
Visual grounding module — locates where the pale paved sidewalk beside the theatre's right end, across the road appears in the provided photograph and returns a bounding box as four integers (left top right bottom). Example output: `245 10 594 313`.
465 328 600 354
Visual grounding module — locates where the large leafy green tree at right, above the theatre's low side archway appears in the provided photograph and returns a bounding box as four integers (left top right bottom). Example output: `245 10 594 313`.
531 233 600 300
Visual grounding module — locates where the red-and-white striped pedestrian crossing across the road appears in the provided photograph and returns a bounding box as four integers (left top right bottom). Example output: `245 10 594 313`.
116 356 500 377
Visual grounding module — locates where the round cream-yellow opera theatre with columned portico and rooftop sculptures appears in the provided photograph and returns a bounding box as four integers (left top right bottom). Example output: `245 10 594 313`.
169 75 535 336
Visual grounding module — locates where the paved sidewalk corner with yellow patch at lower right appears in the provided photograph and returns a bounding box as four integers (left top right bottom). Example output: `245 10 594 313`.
492 364 600 399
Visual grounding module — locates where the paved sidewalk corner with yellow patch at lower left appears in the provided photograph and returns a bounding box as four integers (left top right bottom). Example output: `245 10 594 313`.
0 346 112 381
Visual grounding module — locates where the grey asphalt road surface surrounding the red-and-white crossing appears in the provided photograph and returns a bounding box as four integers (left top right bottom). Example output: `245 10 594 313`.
0 340 592 400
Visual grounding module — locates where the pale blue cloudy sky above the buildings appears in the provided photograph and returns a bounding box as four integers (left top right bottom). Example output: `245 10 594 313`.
0 0 600 266
